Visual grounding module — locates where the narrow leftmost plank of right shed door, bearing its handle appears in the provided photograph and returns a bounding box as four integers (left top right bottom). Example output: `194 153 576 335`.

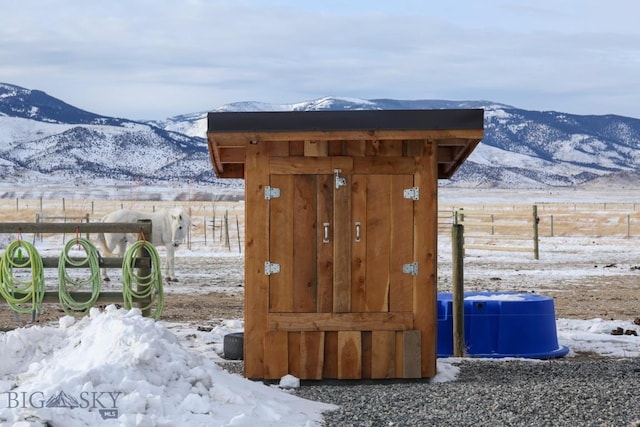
350 175 367 313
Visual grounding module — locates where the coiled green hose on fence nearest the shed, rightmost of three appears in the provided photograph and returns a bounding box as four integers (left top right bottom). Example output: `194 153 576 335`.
122 240 164 319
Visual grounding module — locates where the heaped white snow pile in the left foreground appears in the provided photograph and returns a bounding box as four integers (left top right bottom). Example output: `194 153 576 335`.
0 306 334 426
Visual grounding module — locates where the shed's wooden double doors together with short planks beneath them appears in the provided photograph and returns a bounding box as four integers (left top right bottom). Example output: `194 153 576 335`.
262 169 428 379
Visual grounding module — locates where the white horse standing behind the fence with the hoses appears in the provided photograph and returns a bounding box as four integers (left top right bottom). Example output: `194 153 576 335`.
98 208 191 282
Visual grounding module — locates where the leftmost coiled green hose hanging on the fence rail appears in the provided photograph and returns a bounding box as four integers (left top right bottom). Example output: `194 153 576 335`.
0 240 45 319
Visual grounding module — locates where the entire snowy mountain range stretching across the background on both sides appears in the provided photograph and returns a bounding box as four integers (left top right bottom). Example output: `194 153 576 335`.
0 83 640 197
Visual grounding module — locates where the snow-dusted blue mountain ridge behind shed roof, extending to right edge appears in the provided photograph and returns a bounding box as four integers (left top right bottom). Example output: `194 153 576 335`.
157 98 640 188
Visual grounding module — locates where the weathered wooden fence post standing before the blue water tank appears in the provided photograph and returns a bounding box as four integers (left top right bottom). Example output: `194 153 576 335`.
451 224 465 357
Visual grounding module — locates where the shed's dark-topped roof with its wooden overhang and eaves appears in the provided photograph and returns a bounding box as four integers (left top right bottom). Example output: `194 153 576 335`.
207 109 484 179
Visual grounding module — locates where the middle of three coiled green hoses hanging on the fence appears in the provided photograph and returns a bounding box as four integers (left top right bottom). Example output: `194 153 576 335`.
58 237 100 316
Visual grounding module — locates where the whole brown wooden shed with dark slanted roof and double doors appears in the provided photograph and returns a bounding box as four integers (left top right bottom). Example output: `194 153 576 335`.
207 109 484 379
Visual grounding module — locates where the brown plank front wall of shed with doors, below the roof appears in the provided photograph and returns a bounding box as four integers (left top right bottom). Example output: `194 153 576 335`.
240 141 437 379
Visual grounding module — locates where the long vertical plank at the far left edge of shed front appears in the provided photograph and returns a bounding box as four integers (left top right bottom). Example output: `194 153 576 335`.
244 143 269 378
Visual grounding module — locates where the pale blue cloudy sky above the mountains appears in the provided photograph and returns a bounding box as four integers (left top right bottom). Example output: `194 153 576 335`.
0 0 640 120
